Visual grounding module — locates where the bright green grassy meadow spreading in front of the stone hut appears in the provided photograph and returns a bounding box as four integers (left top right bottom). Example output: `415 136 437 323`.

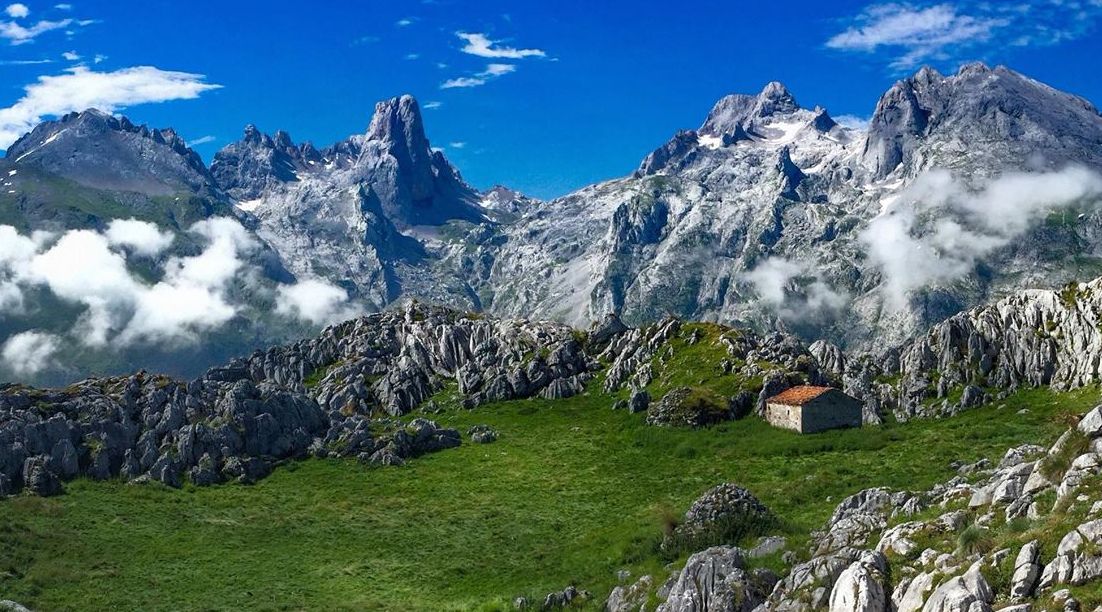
0 386 1098 610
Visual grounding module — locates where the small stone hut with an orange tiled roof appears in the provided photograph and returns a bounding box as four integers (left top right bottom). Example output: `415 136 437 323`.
765 385 862 433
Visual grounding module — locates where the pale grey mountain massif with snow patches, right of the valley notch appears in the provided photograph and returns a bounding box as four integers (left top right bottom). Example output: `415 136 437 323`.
480 64 1102 346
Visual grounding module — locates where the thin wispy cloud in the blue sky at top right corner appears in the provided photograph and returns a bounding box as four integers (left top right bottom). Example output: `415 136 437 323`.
827 0 1102 71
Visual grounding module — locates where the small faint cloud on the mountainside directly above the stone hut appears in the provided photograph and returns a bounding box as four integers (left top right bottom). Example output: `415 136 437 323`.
743 257 850 321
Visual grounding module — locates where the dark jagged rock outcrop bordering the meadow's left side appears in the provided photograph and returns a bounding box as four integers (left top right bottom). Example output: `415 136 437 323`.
0 304 592 495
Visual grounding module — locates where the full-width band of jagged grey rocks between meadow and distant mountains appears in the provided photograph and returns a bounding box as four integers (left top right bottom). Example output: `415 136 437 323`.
0 274 1102 502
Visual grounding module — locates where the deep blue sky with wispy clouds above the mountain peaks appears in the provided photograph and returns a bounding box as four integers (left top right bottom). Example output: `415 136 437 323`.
0 0 1102 197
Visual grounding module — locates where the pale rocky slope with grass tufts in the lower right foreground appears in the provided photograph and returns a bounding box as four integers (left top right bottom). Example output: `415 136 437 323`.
606 407 1102 612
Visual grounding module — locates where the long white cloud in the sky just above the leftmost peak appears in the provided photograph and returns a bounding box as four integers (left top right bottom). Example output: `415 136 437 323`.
0 66 222 148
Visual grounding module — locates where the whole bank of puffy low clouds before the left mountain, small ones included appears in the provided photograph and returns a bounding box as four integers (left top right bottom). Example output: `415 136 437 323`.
0 217 360 375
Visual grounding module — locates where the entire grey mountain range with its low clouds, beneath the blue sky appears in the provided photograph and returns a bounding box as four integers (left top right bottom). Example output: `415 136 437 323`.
0 64 1102 382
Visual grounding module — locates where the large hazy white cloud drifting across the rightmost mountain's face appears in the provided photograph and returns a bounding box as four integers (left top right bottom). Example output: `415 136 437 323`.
861 167 1102 310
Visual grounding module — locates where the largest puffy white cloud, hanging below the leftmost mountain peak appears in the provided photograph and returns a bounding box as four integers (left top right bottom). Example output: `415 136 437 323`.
0 217 256 346
